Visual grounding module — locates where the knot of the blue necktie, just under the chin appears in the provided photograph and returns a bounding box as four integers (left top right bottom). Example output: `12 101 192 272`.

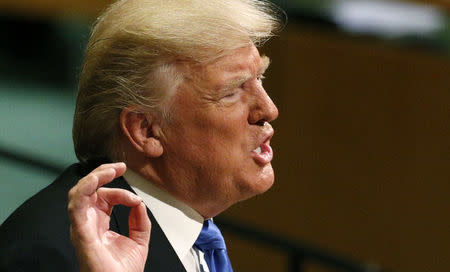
194 219 226 252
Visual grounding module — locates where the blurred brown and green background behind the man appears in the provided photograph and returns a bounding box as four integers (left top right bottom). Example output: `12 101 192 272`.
0 0 450 272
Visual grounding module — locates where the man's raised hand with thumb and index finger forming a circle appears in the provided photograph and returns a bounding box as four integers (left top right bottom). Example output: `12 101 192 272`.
68 163 151 272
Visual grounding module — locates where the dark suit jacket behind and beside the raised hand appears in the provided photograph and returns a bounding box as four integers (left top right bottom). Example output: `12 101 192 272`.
0 164 185 272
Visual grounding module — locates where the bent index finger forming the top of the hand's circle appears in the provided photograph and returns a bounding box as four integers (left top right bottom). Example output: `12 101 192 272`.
97 188 142 211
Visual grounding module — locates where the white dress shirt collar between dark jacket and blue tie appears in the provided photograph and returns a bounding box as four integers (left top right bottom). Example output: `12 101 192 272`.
123 169 209 272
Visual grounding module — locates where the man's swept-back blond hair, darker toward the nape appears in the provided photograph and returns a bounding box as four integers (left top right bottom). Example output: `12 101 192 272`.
73 0 281 161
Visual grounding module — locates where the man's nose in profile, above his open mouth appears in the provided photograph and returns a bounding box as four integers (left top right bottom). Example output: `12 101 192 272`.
248 88 278 126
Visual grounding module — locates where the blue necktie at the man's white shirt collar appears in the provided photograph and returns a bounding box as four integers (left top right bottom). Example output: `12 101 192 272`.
194 219 233 272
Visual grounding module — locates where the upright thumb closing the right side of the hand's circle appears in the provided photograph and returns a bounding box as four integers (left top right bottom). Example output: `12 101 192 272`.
128 202 151 249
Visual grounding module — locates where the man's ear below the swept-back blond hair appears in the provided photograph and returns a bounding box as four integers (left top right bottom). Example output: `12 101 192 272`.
120 108 163 158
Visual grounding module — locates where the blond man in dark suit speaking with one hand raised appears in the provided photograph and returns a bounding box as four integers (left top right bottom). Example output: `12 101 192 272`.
0 0 279 272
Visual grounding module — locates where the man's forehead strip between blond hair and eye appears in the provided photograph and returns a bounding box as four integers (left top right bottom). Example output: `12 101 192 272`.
185 45 269 84
